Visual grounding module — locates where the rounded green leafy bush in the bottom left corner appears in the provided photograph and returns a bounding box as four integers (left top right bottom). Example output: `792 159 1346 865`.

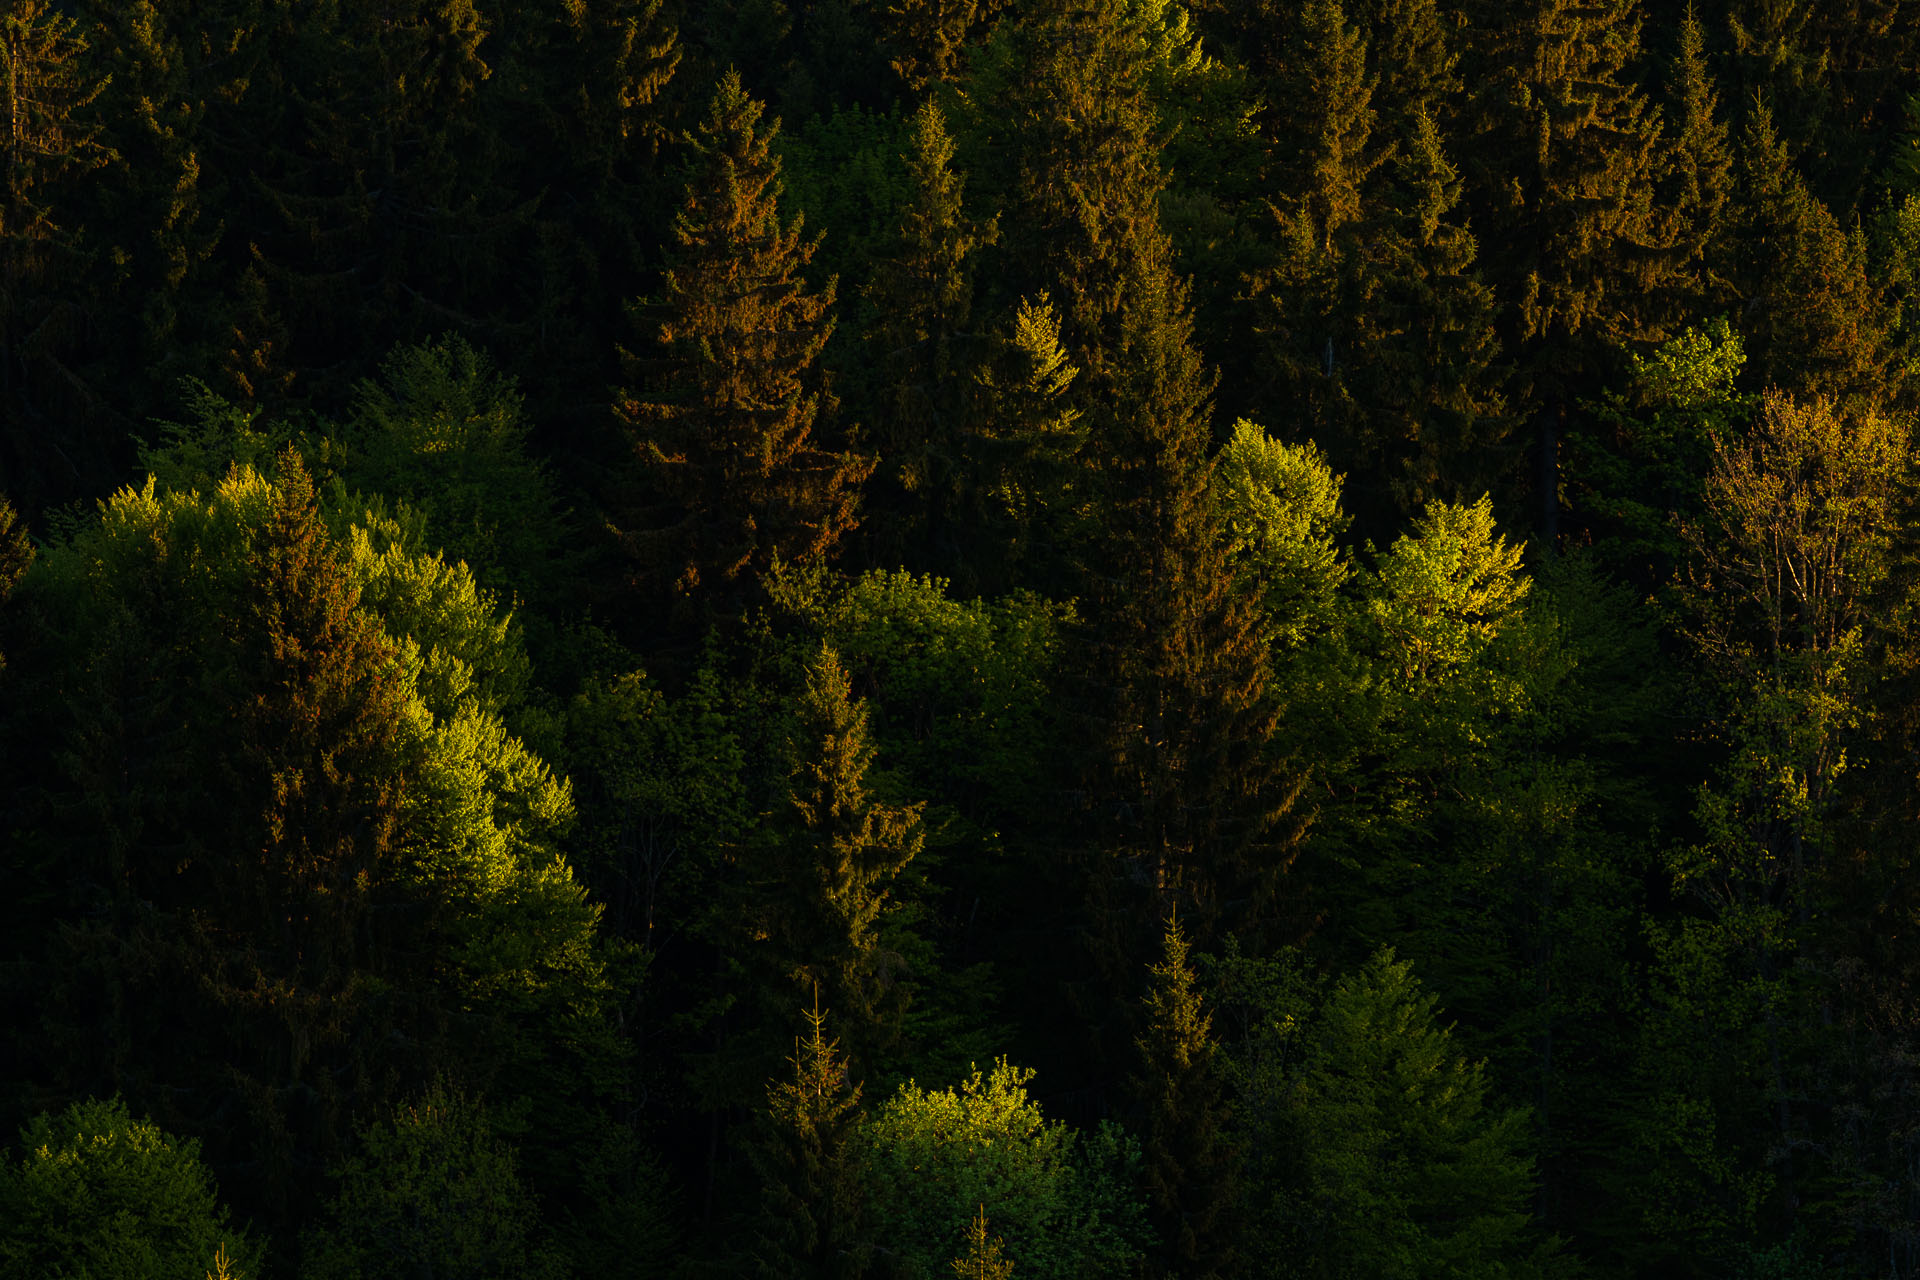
0 1098 263 1280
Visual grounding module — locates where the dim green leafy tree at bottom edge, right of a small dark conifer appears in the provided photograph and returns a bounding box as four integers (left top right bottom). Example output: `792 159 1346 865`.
1227 952 1553 1276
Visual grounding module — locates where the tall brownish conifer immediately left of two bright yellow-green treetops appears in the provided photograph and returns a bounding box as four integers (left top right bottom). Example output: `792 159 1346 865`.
1087 240 1298 951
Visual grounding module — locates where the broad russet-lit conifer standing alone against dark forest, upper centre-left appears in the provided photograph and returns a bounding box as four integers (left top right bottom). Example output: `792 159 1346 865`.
614 73 874 606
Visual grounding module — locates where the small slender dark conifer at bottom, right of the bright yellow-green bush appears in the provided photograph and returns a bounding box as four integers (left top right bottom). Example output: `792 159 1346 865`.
1135 917 1238 1280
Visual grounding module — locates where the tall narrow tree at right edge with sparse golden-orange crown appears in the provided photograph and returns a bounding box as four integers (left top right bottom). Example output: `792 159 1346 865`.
1634 391 1912 1253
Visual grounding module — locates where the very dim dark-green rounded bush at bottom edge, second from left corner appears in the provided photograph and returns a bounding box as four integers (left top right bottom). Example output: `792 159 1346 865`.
301 1084 566 1280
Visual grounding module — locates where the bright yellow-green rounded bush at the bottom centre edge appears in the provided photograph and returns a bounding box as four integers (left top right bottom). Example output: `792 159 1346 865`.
862 1059 1144 1280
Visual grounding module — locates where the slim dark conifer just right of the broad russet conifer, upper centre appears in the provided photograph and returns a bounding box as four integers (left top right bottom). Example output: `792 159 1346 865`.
864 100 996 572
